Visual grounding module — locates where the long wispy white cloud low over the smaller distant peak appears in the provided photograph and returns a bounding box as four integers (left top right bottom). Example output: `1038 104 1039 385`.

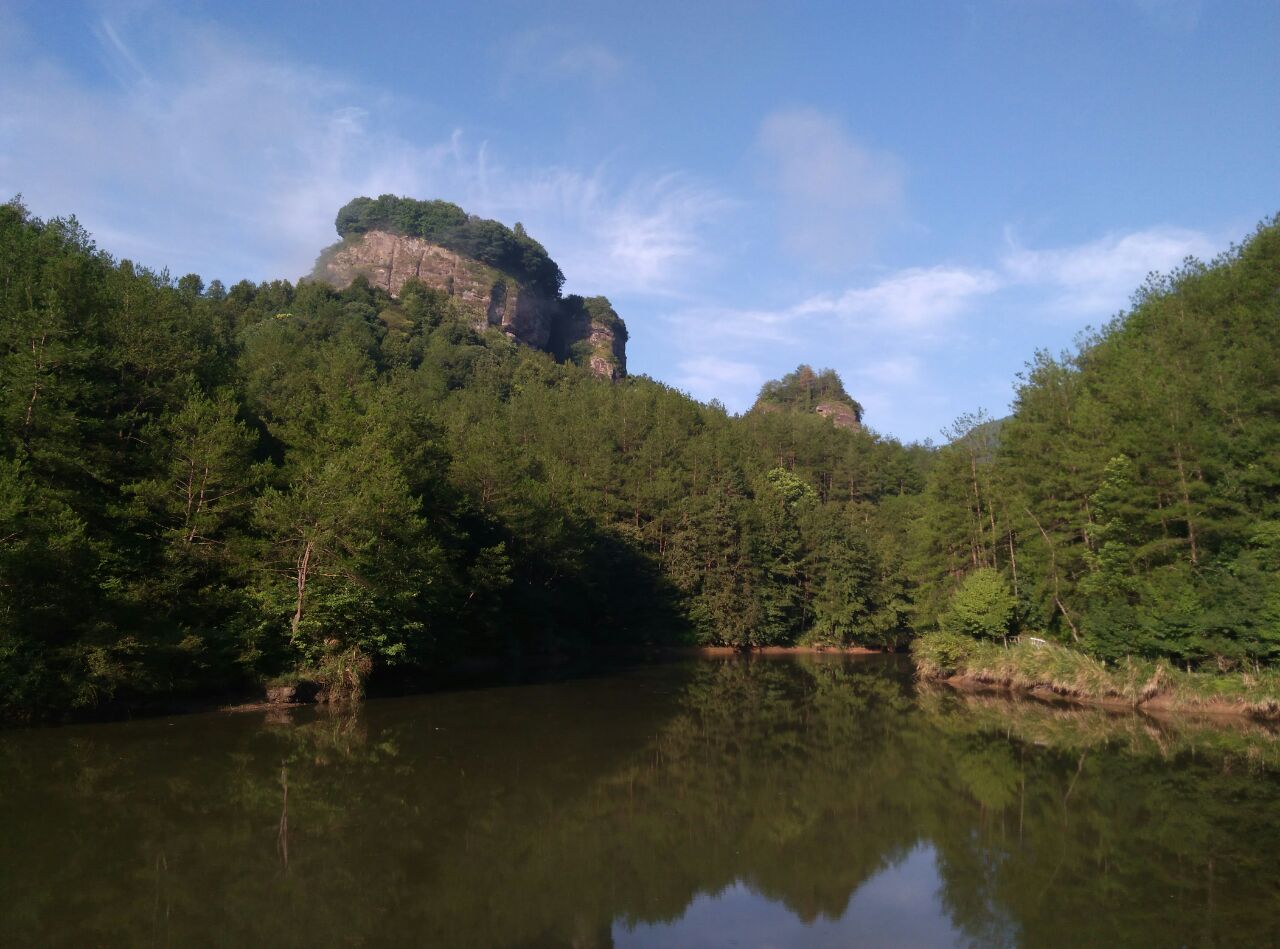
667 220 1219 432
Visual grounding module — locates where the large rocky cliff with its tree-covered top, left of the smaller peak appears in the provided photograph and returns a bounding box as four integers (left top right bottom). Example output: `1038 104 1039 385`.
311 196 627 379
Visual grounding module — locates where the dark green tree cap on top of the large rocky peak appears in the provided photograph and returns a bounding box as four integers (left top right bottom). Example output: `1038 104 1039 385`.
335 195 564 297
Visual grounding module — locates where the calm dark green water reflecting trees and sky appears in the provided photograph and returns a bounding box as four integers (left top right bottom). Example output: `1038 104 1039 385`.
0 657 1280 946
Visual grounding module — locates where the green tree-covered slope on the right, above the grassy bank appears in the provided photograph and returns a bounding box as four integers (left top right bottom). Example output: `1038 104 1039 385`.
911 222 1280 669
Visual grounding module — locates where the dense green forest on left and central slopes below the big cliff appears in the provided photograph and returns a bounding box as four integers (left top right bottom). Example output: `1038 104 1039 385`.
0 204 922 711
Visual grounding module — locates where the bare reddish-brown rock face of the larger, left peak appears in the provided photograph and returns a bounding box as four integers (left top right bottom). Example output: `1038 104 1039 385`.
312 231 627 379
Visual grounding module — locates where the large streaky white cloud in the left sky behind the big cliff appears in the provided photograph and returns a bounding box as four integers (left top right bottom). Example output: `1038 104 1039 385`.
0 12 728 293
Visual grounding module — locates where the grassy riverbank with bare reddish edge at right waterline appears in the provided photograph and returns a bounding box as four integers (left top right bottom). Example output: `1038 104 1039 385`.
911 633 1280 722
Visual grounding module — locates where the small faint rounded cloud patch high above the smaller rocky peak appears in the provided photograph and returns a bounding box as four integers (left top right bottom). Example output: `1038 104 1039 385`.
758 109 902 268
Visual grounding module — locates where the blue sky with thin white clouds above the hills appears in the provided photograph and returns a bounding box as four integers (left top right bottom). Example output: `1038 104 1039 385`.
0 0 1280 441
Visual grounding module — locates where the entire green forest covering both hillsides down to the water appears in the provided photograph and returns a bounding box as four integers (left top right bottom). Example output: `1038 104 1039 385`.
0 200 1280 717
